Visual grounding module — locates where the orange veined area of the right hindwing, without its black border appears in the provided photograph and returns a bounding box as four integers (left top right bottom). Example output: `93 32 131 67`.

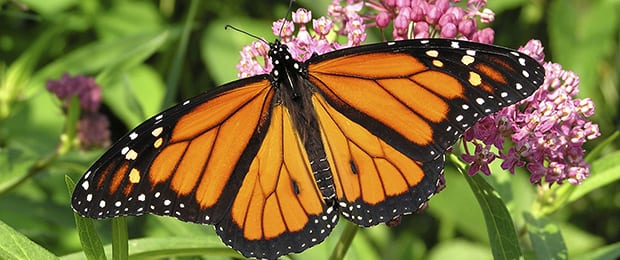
312 94 424 210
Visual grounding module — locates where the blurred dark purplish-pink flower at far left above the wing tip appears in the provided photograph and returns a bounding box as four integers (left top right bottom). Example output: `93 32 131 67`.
46 73 110 149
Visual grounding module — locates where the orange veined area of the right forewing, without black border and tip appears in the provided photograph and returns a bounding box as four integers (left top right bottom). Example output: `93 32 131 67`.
308 53 465 147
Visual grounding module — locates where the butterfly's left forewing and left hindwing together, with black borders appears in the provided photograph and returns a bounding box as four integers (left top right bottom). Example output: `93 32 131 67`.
72 76 338 258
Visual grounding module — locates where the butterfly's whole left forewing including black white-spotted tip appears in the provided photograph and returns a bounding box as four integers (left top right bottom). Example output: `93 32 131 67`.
72 77 273 224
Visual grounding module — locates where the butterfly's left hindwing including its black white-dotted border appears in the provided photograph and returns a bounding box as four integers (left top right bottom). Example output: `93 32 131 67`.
216 104 338 258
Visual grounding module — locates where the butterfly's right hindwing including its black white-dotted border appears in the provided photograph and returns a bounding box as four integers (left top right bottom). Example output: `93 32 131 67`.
313 95 444 226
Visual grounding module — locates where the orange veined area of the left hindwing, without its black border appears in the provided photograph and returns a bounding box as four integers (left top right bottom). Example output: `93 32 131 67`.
231 105 325 240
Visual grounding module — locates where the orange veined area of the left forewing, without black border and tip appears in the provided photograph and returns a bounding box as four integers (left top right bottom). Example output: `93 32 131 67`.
144 80 273 209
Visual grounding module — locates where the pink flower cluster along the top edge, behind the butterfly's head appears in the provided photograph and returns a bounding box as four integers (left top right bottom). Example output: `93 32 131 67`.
237 0 494 78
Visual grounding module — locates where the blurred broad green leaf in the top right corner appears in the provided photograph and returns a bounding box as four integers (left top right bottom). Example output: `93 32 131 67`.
546 0 620 122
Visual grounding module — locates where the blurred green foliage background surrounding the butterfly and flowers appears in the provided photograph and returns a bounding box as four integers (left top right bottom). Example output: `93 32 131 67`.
0 0 620 259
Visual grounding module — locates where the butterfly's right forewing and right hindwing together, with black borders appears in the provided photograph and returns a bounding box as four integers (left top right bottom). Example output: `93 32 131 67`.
307 39 544 226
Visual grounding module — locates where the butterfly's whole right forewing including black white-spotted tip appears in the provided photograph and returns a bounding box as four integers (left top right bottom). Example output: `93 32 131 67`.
308 39 544 161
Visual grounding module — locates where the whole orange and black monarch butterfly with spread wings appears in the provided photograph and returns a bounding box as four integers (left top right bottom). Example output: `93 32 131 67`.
72 39 544 258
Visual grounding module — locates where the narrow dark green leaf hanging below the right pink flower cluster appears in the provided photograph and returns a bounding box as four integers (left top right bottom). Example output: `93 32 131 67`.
462 171 522 259
